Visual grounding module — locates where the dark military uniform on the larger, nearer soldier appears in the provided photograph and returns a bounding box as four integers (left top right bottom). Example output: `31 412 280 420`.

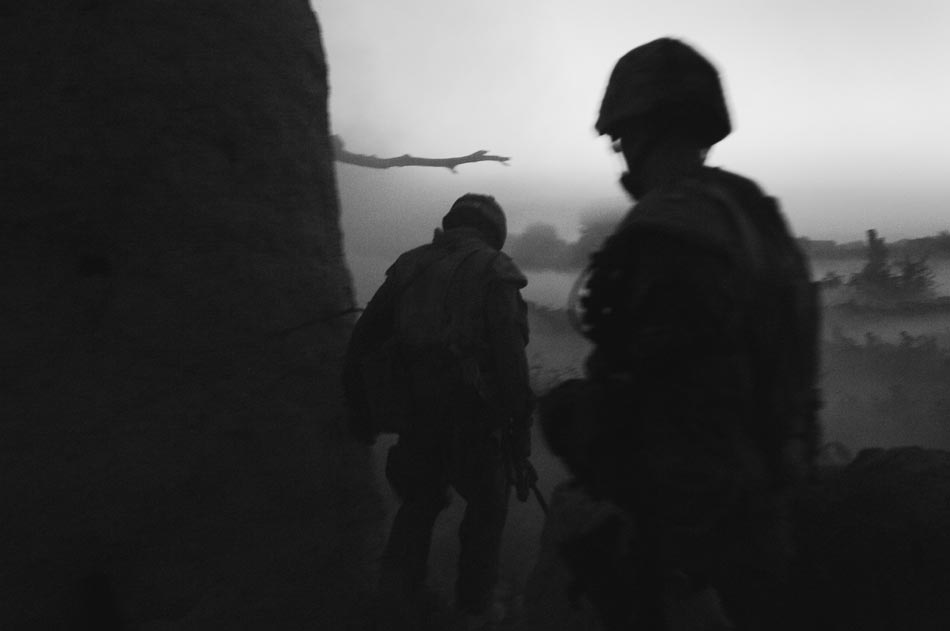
583 167 818 629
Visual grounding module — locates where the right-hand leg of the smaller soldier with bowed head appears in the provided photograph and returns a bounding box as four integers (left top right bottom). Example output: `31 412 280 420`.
455 440 511 614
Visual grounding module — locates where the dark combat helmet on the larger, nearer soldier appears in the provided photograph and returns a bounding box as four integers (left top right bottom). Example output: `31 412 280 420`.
595 37 732 146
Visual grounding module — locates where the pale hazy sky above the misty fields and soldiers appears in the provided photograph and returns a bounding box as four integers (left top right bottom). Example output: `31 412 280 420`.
313 0 950 298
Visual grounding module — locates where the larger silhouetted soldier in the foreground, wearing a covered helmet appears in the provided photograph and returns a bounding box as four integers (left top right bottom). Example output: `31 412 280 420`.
542 38 818 630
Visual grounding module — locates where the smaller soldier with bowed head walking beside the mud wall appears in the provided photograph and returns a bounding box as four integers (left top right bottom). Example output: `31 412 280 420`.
344 193 533 626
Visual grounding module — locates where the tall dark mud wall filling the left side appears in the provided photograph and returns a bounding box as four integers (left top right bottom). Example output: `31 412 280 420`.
0 0 379 629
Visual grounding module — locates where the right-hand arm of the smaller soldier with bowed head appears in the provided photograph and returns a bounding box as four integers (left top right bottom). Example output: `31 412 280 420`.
486 254 534 457
